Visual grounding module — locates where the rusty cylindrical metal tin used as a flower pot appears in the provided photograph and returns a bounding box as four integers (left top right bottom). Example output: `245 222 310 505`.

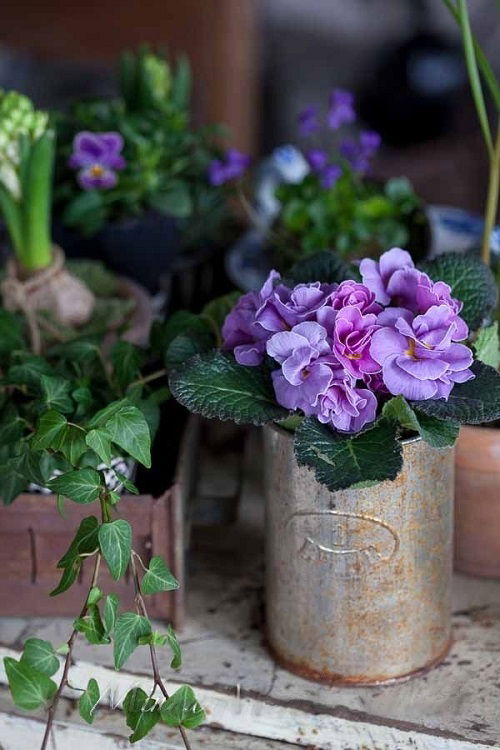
264 427 454 684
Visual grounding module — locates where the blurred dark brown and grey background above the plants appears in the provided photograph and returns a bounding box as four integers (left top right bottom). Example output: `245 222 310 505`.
0 0 500 211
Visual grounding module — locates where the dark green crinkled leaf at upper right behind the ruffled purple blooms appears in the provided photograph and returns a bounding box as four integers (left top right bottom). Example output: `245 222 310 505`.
421 253 498 331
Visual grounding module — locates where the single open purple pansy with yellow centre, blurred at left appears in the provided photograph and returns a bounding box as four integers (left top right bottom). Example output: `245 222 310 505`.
68 131 126 190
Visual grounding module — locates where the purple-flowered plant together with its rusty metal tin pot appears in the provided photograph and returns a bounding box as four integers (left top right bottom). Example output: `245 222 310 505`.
166 248 500 683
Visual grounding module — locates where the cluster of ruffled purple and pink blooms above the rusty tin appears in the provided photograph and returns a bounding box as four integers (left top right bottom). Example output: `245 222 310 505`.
222 248 474 433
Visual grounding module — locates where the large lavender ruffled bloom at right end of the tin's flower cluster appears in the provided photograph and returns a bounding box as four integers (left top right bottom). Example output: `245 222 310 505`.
370 305 474 401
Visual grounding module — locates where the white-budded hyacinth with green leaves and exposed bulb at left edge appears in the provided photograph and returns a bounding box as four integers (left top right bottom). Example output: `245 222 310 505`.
0 91 94 349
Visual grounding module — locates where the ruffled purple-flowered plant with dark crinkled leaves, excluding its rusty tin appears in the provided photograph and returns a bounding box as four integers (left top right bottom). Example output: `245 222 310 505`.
167 248 500 491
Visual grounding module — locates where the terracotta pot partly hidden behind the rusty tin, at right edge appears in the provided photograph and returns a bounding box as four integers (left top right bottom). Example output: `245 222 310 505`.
455 426 500 578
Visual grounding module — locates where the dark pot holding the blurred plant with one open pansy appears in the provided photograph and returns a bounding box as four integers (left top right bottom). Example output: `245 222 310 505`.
53 211 181 293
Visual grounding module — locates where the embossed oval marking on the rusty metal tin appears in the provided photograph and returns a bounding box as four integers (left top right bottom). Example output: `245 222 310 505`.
285 510 399 577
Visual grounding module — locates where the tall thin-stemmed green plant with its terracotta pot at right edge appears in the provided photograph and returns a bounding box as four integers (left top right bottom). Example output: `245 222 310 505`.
444 0 500 577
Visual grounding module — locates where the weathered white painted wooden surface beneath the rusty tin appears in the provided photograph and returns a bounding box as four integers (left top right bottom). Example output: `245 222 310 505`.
0 428 500 750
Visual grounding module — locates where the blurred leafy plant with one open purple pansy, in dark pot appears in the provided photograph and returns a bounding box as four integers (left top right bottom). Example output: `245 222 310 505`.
55 48 233 291
